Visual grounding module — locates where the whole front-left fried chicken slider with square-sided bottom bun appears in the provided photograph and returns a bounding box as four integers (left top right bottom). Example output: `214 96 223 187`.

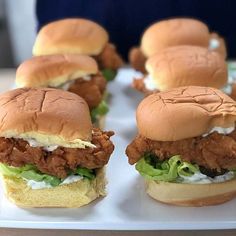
0 88 114 207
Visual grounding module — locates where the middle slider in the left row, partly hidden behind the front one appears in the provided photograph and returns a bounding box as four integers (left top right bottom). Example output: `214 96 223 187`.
15 54 109 128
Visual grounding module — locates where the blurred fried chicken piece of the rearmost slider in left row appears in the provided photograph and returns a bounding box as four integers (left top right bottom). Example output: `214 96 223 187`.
94 43 124 70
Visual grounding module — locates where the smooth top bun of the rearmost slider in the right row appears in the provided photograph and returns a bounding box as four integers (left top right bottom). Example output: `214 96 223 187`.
141 18 210 57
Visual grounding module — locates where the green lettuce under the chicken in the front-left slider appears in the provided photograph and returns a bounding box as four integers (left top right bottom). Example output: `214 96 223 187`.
0 163 96 187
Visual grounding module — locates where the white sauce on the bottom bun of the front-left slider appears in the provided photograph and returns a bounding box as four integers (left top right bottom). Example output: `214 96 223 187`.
25 175 83 189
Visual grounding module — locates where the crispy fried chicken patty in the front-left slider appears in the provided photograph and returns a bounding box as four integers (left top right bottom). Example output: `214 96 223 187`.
0 128 114 178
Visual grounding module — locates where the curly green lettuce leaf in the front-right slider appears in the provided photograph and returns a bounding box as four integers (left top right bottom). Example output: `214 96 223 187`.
135 154 199 182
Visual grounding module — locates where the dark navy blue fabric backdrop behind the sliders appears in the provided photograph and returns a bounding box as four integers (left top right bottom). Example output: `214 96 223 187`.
36 0 236 58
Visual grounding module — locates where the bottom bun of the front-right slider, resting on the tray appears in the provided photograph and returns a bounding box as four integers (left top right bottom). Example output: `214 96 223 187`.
146 179 236 206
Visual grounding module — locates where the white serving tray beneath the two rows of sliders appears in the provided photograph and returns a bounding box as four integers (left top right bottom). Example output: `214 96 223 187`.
0 69 236 230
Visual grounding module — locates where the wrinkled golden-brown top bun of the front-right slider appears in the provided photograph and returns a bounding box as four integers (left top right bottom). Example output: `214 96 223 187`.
136 86 236 141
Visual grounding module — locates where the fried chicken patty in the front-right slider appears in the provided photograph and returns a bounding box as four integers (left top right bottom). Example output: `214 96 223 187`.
126 130 236 172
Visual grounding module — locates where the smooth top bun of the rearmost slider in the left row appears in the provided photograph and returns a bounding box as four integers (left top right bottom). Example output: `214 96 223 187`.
33 18 108 56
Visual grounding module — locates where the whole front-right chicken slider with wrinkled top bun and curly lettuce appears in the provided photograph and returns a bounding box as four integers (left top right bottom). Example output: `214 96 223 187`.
126 86 236 206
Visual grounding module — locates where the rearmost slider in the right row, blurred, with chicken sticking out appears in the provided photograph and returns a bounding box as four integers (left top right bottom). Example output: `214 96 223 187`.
129 18 226 73
